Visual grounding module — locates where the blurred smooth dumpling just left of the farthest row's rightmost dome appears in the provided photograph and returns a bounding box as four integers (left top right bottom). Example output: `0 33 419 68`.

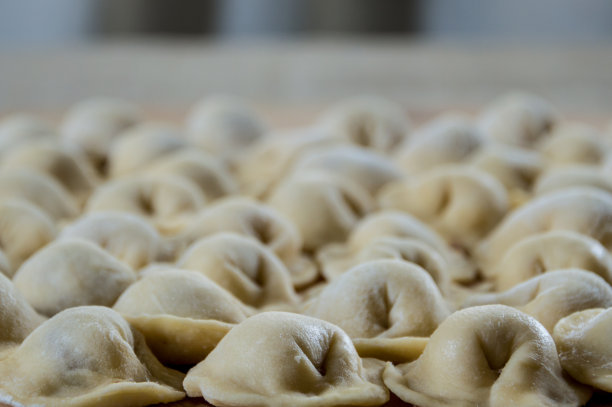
394 114 486 174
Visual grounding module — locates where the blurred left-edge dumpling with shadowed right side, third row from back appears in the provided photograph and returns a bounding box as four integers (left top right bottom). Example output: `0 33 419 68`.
2 140 98 204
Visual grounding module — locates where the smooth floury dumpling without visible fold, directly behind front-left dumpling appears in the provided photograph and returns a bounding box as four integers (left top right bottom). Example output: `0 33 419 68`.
13 239 136 316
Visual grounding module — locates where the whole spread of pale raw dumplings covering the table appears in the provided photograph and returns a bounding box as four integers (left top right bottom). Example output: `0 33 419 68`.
0 93 612 407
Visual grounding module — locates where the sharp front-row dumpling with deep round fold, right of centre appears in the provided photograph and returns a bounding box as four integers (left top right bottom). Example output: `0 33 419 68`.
383 305 591 407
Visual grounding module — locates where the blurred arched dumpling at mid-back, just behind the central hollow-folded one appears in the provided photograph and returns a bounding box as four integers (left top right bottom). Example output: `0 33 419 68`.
293 146 402 195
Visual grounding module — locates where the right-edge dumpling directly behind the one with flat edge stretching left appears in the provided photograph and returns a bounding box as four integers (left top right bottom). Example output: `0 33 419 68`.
488 230 612 291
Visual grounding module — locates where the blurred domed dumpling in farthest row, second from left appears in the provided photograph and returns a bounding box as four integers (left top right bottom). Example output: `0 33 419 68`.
61 98 142 172
